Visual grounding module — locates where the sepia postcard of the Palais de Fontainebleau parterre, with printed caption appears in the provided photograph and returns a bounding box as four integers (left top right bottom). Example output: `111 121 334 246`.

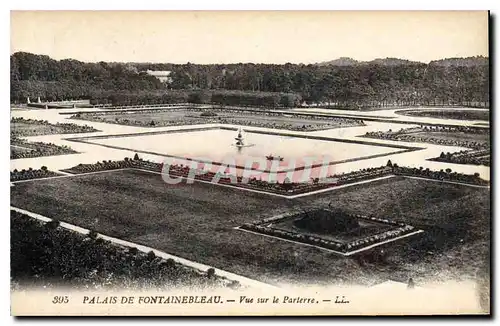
10 11 491 316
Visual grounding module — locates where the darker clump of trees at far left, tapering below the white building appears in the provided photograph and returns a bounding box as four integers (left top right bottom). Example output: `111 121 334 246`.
10 52 165 102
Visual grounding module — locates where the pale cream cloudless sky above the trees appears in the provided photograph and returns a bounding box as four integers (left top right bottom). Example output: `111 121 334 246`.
11 11 488 64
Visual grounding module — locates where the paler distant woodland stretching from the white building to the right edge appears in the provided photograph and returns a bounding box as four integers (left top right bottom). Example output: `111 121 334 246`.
132 57 489 107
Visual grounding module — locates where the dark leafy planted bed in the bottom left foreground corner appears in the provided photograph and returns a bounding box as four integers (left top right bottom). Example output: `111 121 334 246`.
11 210 239 289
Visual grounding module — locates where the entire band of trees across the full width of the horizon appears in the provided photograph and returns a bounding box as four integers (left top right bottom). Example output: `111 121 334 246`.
11 52 489 108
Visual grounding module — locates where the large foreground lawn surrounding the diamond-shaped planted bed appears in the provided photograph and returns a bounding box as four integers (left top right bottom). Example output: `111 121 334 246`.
11 170 490 284
